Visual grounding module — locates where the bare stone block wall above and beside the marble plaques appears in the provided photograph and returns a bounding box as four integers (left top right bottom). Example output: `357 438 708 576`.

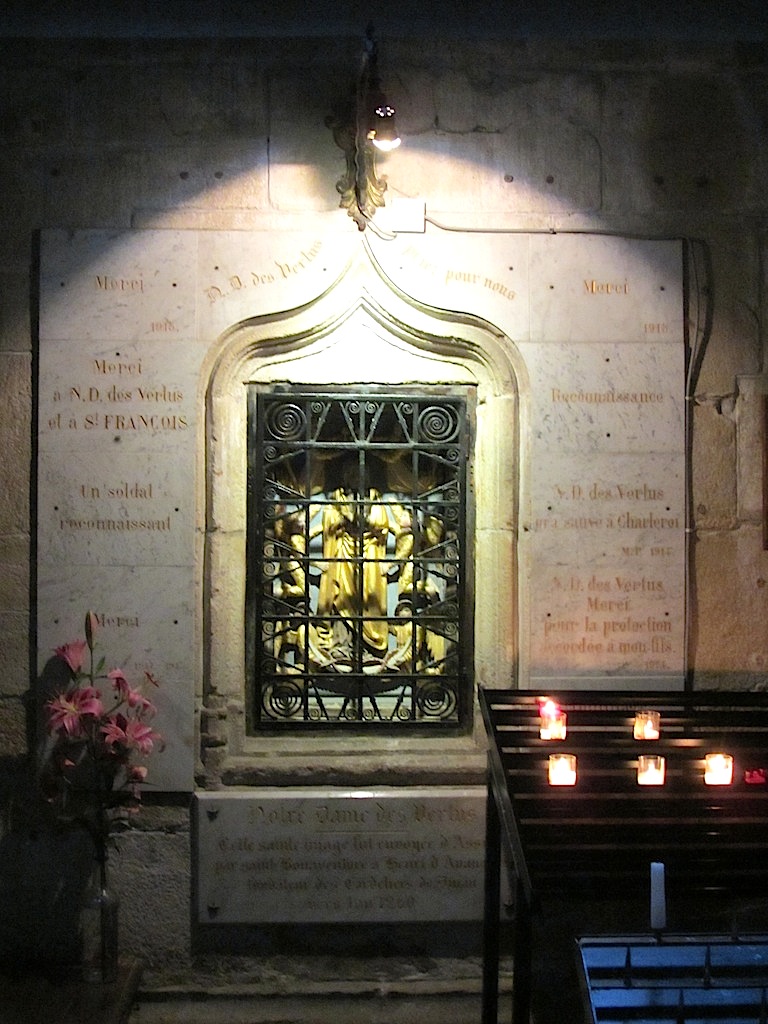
0 19 768 973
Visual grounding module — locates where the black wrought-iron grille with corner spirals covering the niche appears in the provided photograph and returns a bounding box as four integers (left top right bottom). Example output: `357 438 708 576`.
246 385 471 731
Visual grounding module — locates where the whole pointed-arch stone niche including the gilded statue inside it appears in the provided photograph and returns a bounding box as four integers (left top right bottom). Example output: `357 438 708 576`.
201 258 523 781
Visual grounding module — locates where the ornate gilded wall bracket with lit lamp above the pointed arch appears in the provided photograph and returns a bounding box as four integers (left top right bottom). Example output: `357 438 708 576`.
326 25 400 231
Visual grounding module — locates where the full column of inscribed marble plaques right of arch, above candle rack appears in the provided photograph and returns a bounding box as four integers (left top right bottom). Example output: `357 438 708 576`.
520 237 686 688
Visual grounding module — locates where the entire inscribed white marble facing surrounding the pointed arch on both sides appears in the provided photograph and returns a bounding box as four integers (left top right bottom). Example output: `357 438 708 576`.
37 228 686 794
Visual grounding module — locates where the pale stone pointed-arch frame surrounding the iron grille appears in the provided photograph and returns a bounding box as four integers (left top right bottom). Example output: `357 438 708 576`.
200 249 524 784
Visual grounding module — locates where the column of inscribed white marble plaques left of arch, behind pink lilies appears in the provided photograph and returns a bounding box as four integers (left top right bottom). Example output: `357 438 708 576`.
37 231 207 791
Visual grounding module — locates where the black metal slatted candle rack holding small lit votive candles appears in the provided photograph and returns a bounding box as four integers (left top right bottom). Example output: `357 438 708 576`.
480 690 768 1024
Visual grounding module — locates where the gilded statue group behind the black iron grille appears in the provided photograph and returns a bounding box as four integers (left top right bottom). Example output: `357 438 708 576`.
273 460 445 676
